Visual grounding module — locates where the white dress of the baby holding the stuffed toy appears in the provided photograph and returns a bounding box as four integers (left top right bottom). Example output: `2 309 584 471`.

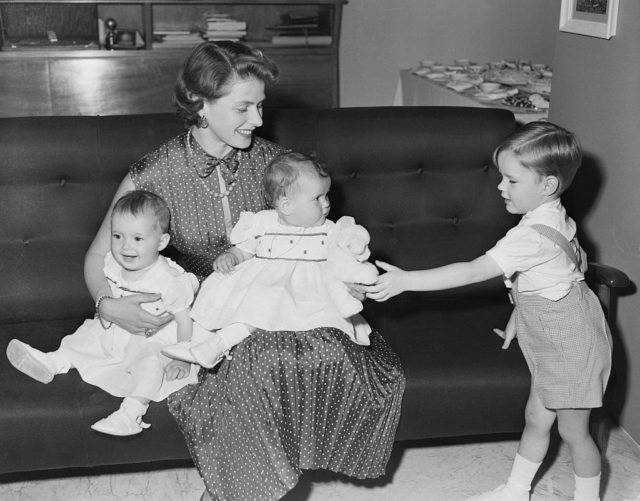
191 210 371 345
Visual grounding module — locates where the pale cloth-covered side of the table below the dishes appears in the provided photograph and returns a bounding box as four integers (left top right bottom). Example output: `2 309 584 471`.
393 69 549 124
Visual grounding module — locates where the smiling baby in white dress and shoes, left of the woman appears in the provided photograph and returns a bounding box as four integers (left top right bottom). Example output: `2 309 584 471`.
7 190 198 436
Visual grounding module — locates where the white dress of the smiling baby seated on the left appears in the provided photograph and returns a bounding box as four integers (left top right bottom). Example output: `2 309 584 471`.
58 253 199 402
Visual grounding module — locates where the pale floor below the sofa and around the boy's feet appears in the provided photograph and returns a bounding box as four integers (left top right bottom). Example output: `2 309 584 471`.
0 422 640 501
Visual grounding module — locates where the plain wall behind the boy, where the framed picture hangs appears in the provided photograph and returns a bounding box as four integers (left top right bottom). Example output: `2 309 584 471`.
549 0 640 442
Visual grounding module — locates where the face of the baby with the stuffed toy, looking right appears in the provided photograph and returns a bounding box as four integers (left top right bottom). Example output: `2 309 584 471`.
286 172 331 228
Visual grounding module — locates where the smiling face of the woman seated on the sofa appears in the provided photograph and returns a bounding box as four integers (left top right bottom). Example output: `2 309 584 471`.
199 78 265 157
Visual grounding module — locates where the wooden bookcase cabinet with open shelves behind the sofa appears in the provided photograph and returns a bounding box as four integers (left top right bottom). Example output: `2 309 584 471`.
0 0 346 117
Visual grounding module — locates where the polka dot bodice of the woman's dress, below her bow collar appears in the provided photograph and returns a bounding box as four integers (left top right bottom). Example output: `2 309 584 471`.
130 133 286 279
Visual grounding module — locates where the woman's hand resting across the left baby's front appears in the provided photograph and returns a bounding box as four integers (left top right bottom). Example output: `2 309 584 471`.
99 294 173 337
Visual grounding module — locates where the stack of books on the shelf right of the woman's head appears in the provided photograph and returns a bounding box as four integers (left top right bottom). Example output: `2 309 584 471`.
269 7 333 46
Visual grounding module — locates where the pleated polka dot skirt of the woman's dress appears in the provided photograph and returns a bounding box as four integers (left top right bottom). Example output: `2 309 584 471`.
168 328 404 501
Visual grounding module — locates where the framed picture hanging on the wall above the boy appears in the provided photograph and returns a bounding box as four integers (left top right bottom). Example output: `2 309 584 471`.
560 0 618 38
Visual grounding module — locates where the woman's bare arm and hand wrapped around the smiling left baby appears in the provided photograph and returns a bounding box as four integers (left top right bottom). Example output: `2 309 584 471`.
84 175 173 335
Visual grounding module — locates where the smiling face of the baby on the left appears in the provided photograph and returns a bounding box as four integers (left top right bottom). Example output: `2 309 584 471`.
111 209 169 271
